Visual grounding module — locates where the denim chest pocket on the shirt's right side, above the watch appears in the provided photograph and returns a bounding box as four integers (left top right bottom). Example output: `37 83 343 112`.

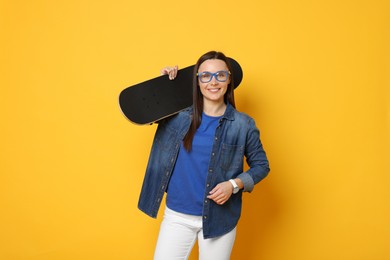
221 143 244 171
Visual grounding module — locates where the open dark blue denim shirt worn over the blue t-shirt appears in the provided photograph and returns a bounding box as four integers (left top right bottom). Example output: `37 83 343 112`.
138 104 270 239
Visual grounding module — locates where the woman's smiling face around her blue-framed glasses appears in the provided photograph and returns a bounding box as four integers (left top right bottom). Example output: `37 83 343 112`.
198 59 230 103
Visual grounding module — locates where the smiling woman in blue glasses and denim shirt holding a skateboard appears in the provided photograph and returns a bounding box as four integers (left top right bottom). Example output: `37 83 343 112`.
138 51 269 260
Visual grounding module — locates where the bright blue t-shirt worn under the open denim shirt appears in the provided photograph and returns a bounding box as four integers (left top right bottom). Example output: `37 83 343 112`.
167 113 221 216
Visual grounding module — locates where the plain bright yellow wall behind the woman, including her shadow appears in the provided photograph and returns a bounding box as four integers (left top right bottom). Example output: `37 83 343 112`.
0 0 390 260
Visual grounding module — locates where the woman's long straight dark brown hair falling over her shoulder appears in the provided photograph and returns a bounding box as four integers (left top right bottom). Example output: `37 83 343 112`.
183 51 236 151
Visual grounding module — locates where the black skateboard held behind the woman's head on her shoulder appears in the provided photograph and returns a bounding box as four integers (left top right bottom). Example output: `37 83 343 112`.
119 58 243 125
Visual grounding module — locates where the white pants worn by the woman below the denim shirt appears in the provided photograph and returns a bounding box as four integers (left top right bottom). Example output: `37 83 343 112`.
154 207 236 260
